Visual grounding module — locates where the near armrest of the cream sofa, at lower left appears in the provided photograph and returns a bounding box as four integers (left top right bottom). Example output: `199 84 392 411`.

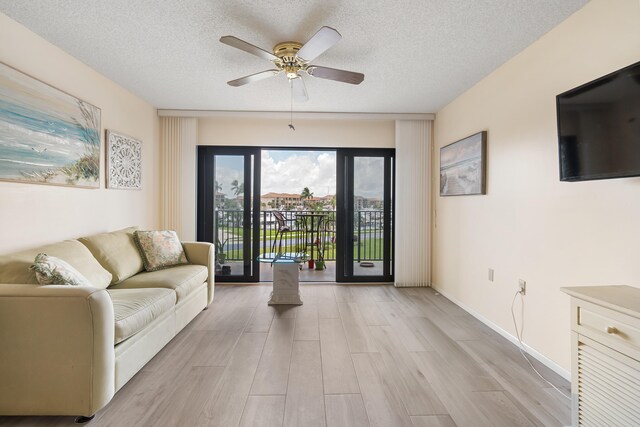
0 284 115 416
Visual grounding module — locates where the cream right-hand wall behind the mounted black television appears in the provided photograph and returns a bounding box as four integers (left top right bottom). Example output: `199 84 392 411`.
432 0 640 370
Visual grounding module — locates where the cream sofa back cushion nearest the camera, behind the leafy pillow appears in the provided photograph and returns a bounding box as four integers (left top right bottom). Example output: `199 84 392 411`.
0 240 111 289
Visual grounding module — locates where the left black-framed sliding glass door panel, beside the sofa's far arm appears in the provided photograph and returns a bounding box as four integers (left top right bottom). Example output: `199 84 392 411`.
197 146 260 282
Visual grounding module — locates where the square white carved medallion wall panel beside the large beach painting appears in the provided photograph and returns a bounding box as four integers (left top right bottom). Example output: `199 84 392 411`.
106 130 142 190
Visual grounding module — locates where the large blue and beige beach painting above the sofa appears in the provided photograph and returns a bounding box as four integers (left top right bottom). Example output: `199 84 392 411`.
0 63 101 188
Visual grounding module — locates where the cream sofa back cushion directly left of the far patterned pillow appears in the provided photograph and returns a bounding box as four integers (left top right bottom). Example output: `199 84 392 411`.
78 227 144 283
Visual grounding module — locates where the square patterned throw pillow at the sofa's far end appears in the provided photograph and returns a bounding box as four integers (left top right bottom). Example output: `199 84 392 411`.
133 230 189 271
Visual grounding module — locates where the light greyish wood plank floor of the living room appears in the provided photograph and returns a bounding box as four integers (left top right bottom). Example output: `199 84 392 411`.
0 284 570 427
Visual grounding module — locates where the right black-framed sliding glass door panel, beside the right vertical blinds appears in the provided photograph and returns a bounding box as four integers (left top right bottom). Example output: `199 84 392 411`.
336 149 394 282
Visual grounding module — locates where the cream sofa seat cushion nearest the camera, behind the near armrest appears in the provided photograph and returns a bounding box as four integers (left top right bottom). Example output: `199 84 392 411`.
107 288 176 344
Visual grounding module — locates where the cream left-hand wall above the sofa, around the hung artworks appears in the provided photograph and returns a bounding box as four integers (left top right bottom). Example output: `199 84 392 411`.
0 13 159 253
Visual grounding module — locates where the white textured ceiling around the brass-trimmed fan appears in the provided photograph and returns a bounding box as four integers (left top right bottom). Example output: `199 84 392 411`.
0 0 586 113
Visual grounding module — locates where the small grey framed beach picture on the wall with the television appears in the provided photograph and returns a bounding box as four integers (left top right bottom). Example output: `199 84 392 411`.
440 131 487 196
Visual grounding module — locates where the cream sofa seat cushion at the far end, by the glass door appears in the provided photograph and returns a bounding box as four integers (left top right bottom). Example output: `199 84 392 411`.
109 264 208 302
